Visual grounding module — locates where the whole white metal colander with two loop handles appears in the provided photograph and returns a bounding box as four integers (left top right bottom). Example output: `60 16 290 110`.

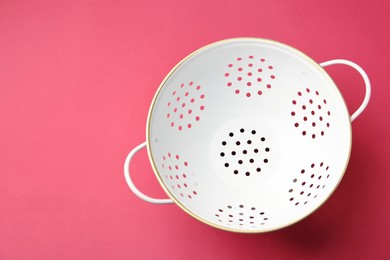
124 38 371 233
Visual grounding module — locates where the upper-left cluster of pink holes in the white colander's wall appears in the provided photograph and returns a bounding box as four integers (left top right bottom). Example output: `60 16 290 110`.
166 81 205 131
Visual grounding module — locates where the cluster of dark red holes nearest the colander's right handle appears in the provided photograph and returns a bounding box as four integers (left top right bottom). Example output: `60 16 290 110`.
290 88 331 139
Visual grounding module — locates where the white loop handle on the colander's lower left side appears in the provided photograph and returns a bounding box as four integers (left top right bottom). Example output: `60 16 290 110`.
124 142 173 204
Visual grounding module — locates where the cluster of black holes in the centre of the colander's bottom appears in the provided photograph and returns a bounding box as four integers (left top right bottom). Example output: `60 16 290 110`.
219 128 271 177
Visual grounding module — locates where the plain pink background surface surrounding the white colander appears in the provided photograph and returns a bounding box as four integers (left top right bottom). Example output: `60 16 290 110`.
0 0 390 260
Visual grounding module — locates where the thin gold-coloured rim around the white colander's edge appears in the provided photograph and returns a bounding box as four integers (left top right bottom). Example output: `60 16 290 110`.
146 37 352 234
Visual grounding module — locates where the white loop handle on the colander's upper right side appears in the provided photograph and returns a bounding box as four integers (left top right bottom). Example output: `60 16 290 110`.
320 59 371 122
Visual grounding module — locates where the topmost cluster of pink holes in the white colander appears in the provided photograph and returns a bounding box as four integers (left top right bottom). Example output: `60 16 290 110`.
224 55 276 98
